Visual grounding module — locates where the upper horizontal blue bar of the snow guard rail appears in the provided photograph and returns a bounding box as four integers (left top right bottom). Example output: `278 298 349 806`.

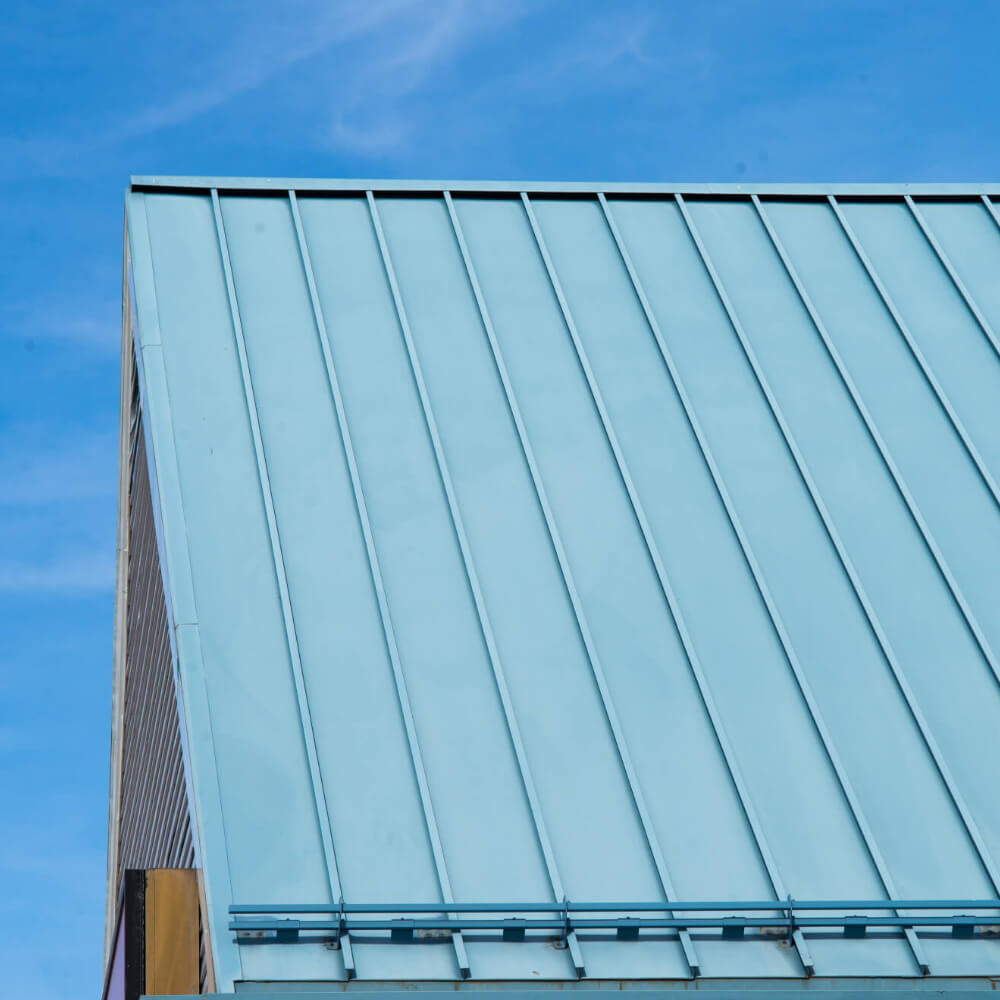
229 899 1000 915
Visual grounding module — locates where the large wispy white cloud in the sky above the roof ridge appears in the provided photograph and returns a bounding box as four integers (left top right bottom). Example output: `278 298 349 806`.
0 0 680 174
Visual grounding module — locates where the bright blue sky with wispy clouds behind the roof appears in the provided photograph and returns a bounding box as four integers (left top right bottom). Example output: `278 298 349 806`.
0 0 1000 998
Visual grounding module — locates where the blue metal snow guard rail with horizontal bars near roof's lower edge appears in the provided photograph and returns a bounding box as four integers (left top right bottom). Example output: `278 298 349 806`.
229 897 1000 944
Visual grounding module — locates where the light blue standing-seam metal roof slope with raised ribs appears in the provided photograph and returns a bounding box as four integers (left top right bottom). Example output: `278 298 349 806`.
127 178 1000 988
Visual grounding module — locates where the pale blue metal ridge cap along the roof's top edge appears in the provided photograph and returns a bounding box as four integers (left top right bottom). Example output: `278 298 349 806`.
129 174 1000 198
